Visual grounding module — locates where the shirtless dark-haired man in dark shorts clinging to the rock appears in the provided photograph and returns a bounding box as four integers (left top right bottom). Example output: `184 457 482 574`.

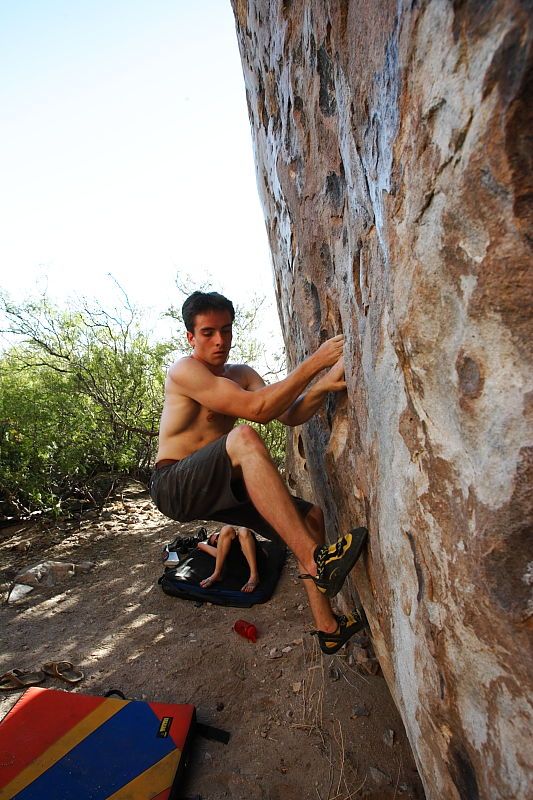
150 292 367 653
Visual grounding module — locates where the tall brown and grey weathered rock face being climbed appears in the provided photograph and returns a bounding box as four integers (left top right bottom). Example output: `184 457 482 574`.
232 0 533 800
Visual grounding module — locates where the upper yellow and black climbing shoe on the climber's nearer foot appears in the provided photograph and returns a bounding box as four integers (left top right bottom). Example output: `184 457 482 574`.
299 528 368 597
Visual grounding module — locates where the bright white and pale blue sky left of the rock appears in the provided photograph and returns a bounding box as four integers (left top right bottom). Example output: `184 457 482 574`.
0 0 273 338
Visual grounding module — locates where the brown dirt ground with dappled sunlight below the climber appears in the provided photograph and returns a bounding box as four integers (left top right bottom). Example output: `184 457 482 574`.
0 484 424 800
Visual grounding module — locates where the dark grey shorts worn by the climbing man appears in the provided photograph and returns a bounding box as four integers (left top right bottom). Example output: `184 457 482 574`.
150 435 312 539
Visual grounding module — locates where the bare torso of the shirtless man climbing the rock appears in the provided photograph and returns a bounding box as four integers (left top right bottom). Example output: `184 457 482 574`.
156 356 255 461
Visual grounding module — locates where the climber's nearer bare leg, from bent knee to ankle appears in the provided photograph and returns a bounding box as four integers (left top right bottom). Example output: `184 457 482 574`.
226 425 316 575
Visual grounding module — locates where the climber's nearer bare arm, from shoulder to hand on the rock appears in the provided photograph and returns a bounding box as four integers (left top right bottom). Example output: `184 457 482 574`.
169 336 344 423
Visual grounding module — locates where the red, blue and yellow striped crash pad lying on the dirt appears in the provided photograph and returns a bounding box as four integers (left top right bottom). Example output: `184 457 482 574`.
0 687 195 800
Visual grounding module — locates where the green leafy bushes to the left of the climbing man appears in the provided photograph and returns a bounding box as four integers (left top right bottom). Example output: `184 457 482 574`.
0 294 175 513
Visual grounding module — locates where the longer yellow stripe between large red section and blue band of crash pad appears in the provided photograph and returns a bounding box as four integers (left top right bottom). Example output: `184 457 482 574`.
0 698 130 798
